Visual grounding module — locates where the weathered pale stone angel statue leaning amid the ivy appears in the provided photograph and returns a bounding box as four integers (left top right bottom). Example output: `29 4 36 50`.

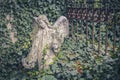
22 15 69 70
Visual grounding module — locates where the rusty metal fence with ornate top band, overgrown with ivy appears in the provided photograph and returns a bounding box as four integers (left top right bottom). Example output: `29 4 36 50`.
66 0 120 54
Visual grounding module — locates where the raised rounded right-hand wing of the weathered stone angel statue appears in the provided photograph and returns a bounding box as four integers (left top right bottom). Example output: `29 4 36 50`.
53 16 69 37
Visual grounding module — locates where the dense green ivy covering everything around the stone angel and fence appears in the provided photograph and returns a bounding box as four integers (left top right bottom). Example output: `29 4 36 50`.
0 0 120 80
